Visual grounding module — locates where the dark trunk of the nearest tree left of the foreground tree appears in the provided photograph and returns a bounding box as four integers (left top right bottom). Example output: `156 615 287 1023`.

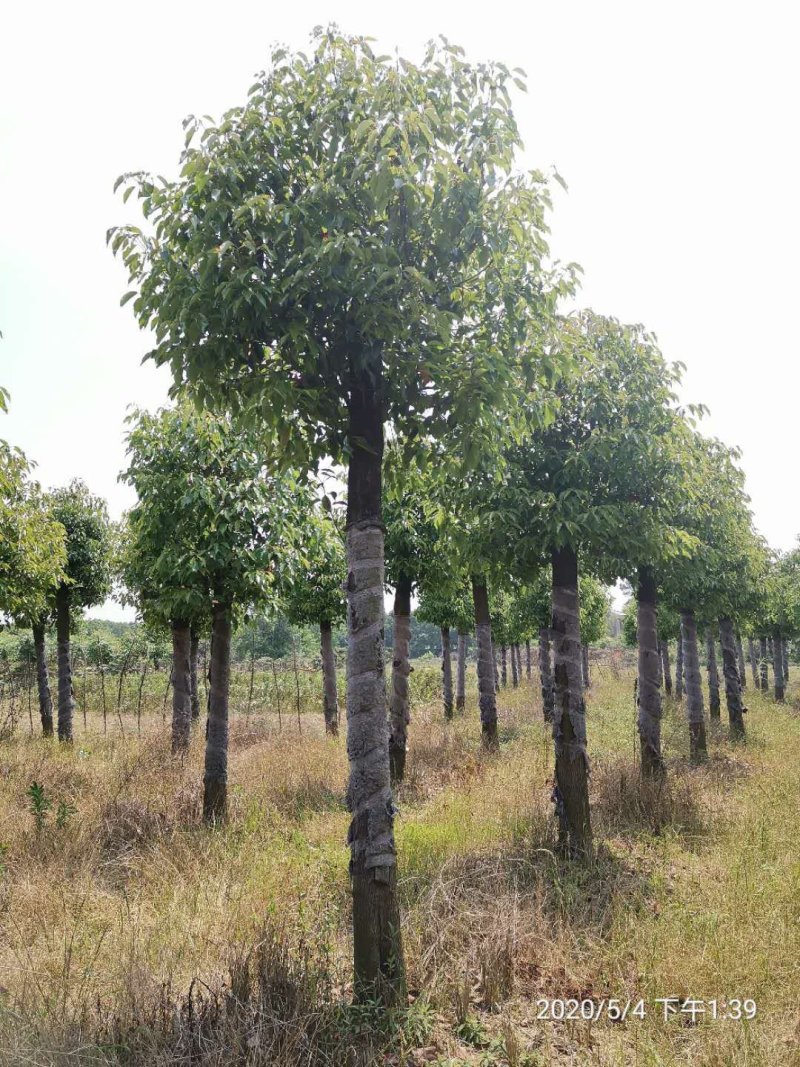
203 604 230 823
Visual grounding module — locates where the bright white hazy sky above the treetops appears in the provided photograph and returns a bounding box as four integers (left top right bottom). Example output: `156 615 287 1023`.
0 0 800 614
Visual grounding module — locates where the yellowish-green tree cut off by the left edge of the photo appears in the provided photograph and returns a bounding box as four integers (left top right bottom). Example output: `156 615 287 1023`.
0 433 66 737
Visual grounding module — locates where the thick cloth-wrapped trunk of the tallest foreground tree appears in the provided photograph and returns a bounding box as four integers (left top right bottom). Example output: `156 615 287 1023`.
347 362 407 1004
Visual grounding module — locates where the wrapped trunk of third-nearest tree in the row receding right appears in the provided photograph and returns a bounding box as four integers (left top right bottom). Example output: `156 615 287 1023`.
636 567 663 778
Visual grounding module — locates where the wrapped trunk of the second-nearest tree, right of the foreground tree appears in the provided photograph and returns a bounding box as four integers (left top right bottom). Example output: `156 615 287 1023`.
551 547 592 856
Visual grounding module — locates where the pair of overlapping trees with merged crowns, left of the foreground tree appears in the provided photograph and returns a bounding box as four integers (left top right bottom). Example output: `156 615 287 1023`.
121 403 302 802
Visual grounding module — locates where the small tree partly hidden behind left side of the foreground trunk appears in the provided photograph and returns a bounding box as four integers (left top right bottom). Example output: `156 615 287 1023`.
278 497 347 736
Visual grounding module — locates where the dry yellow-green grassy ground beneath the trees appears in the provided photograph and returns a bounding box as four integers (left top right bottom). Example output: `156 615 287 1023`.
0 669 800 1067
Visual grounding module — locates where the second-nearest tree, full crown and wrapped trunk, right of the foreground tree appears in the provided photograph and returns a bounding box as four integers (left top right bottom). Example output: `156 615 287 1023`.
487 312 695 855
